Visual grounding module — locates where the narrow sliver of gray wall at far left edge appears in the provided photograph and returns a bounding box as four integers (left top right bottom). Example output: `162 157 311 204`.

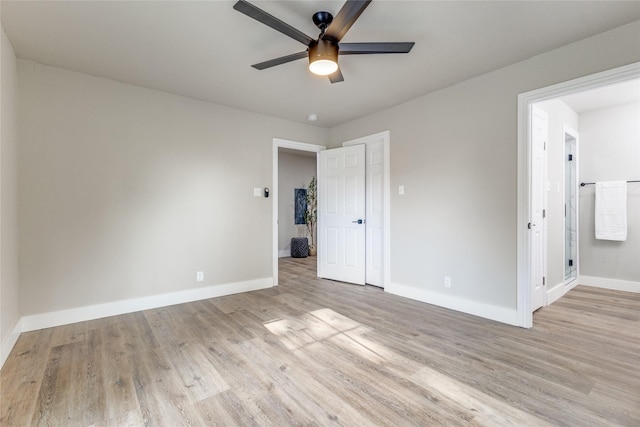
0 25 20 356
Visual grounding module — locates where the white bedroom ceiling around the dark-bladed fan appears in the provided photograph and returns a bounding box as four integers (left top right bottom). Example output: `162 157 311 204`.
1 0 640 127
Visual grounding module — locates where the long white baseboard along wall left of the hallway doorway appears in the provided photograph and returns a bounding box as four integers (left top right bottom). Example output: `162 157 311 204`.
21 277 273 332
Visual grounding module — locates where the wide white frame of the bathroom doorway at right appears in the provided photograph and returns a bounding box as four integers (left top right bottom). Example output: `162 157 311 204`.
516 62 640 328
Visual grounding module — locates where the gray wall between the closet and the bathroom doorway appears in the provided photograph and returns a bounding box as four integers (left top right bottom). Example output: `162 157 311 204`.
330 22 640 310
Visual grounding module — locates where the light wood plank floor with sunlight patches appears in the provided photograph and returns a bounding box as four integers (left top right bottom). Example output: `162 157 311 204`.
0 258 640 426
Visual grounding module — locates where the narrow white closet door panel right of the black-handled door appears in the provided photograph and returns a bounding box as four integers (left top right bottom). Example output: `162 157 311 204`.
365 141 385 287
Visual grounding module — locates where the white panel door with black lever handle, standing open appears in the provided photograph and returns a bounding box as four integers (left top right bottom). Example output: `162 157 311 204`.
318 145 366 285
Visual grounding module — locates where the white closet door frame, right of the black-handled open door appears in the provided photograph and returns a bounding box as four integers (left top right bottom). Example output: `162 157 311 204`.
342 130 391 289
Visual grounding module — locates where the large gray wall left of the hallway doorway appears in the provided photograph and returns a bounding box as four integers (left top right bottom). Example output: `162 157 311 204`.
18 60 328 315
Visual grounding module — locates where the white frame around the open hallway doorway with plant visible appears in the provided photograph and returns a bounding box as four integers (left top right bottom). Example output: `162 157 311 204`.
271 138 327 286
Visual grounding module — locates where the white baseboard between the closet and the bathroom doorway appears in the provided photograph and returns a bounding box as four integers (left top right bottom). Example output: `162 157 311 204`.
384 282 520 326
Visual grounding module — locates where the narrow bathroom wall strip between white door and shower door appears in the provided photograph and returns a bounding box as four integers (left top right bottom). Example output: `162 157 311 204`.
536 99 580 289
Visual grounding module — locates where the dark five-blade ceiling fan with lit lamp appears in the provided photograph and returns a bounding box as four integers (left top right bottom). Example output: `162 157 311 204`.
233 0 415 83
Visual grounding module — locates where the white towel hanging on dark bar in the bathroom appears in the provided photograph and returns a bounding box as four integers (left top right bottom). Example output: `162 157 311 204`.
595 181 627 242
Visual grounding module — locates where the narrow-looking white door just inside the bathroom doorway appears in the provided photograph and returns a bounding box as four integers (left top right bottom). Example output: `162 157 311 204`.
530 106 548 312
